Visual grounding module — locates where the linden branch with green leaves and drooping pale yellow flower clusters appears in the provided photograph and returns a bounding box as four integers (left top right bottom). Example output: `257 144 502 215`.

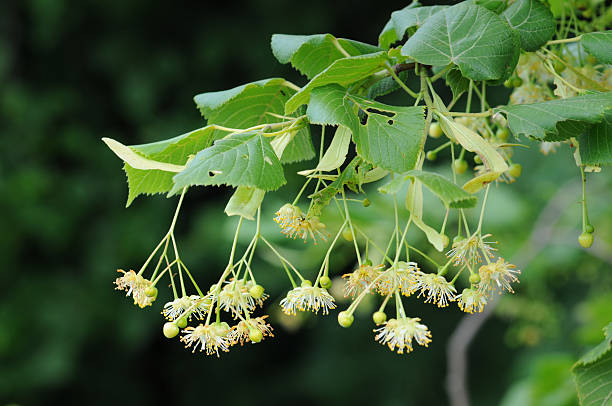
105 2 612 356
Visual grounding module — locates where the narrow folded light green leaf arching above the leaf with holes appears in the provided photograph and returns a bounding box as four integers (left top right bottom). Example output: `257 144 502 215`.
285 52 387 114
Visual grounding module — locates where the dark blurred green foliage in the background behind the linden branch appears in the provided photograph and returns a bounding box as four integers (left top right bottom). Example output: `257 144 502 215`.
0 0 612 405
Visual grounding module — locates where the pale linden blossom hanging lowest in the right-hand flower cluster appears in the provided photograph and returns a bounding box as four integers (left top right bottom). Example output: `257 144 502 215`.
374 317 431 354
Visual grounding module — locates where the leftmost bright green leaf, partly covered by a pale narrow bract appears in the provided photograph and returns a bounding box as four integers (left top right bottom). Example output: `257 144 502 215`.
104 126 214 207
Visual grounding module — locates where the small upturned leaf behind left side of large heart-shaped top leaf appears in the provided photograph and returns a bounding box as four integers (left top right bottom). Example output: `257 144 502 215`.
378 3 447 49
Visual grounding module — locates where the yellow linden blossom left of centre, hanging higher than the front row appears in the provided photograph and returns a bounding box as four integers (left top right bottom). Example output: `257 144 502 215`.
274 203 327 244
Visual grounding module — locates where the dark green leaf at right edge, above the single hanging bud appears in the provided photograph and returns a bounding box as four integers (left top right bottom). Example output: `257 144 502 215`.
578 109 612 165
